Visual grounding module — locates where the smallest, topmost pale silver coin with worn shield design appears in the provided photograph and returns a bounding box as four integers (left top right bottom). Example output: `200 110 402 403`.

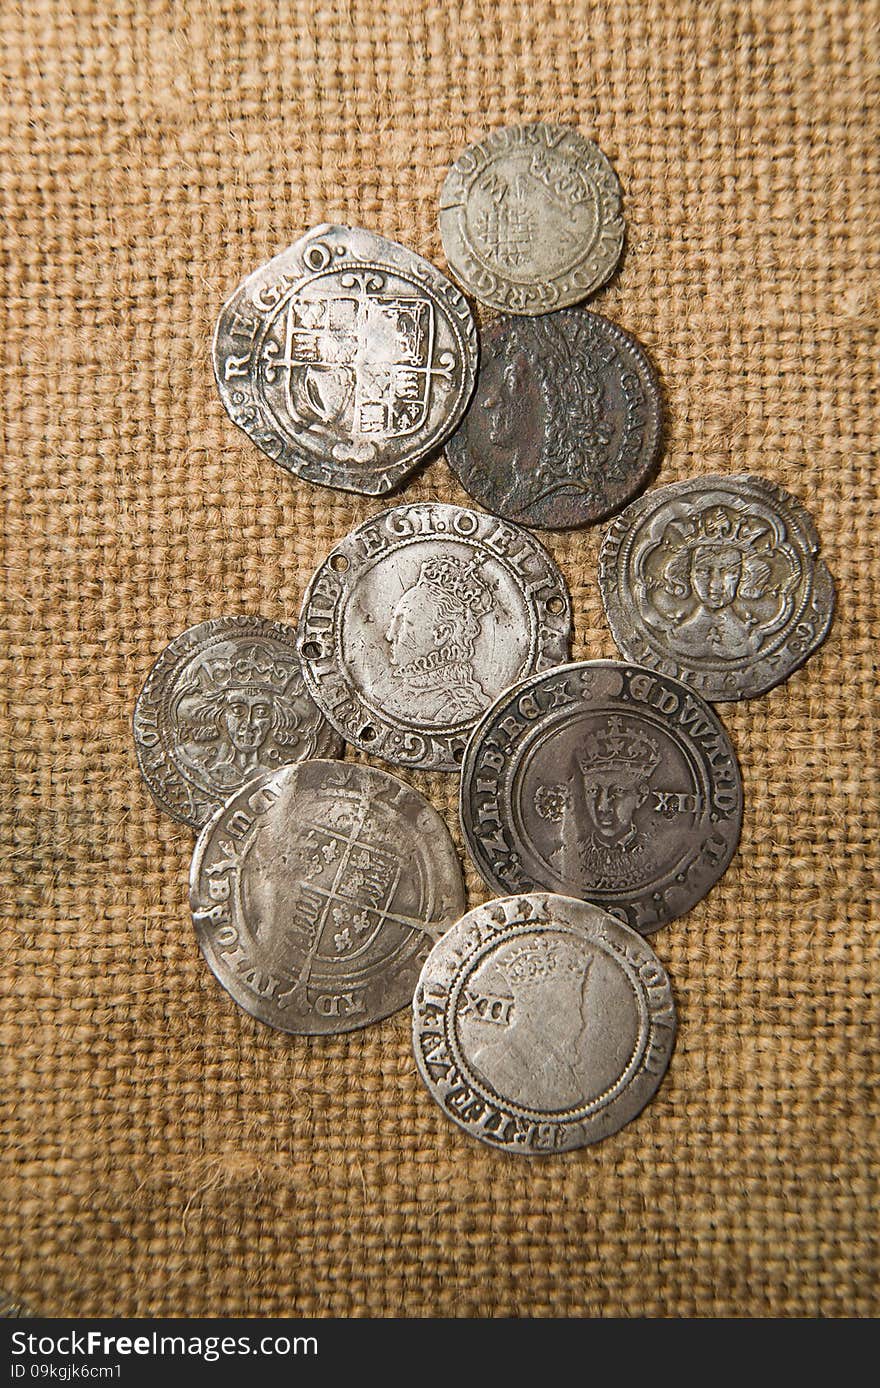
440 121 623 315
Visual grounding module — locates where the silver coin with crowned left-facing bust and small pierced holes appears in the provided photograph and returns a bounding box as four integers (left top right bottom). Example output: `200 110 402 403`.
300 502 570 770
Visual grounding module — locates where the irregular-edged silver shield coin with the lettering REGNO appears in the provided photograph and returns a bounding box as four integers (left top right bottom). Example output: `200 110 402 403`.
214 226 477 496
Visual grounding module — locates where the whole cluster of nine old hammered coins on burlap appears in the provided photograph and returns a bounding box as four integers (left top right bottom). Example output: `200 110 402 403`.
135 122 834 1155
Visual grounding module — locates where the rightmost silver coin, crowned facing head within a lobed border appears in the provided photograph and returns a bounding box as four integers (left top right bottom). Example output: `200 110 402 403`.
600 475 834 700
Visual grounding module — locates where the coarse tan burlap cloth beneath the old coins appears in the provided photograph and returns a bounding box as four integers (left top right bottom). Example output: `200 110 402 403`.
0 0 880 1316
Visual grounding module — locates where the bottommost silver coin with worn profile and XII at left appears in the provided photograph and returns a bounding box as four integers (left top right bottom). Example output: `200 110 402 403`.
412 892 676 1156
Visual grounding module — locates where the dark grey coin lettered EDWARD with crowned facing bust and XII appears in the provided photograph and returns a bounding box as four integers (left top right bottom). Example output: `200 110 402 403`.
461 661 743 934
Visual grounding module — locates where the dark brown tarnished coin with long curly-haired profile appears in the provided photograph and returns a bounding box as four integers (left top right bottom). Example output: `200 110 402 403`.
446 308 661 529
